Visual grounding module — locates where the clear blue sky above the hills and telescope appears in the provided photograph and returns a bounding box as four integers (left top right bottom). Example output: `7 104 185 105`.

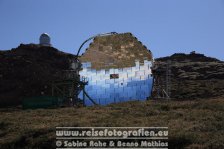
0 0 224 60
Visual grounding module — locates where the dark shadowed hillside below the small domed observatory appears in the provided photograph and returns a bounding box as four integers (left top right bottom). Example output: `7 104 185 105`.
0 44 77 107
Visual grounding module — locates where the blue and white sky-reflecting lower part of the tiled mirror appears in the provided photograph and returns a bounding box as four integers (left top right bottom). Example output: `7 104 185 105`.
79 60 152 105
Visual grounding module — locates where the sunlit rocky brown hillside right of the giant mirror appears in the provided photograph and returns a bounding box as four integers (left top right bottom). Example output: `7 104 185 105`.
156 52 224 99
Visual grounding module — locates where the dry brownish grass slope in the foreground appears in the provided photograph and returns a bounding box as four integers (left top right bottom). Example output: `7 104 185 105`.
0 97 224 149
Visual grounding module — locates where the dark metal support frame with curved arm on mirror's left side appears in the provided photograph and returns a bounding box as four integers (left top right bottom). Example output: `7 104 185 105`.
52 32 117 106
